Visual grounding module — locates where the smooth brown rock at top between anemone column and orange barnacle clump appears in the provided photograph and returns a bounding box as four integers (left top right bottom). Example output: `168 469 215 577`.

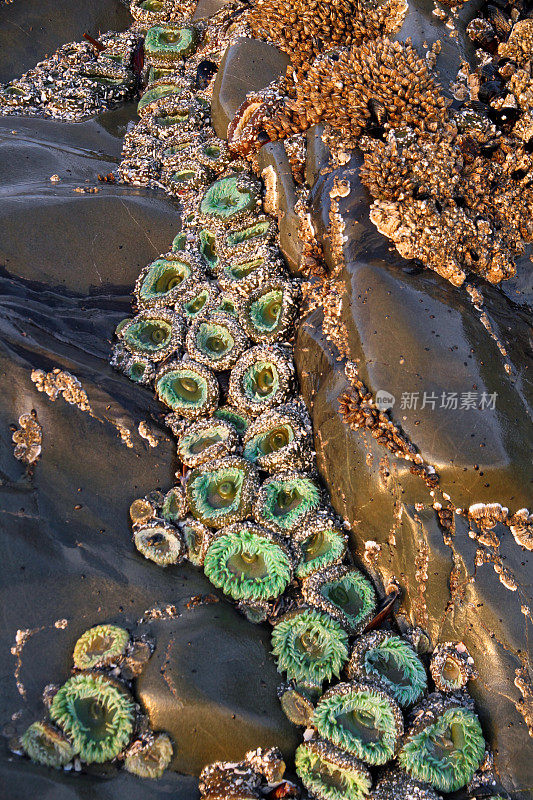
211 37 289 139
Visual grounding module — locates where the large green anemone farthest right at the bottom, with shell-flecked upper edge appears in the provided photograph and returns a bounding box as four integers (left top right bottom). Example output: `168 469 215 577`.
398 694 485 792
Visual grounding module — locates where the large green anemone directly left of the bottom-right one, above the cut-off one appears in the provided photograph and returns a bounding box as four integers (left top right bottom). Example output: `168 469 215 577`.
313 683 403 765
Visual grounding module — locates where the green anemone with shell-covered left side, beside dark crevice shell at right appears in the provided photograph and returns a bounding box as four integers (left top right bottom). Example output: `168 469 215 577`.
302 565 376 633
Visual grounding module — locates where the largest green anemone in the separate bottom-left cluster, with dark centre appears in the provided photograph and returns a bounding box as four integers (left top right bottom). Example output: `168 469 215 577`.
50 672 135 764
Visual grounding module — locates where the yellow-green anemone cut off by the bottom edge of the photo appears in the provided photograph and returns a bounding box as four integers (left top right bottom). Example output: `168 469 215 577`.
295 739 372 800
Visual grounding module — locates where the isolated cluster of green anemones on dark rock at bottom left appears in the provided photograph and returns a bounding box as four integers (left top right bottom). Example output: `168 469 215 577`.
13 624 173 778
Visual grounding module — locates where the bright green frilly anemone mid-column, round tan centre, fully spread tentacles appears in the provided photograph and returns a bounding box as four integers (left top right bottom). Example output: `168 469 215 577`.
204 522 292 600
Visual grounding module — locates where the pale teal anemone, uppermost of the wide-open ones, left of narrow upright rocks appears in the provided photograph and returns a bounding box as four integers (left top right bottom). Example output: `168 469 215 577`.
199 175 261 227
